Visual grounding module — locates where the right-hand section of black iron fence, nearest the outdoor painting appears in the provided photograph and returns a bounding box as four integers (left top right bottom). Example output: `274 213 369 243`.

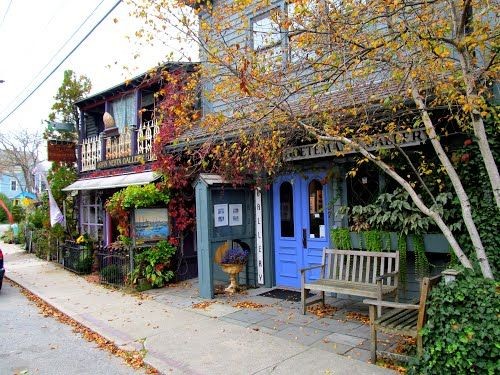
97 249 130 286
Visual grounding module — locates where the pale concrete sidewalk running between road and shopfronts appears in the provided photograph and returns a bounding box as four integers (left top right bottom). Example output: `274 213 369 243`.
0 244 393 375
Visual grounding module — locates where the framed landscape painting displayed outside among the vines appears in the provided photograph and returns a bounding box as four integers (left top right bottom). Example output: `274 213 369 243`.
134 208 170 242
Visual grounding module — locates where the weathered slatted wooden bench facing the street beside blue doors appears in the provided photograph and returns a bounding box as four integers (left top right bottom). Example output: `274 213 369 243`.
300 248 399 315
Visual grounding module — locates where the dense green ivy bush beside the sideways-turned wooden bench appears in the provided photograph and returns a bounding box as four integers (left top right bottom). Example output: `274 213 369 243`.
409 271 500 374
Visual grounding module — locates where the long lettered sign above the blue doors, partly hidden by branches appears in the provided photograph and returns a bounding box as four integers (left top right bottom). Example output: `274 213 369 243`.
284 129 427 161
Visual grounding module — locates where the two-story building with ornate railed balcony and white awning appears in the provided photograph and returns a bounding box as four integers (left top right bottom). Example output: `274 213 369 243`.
63 62 196 280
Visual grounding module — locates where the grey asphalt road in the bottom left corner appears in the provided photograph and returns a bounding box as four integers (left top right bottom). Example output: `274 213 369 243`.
0 280 143 375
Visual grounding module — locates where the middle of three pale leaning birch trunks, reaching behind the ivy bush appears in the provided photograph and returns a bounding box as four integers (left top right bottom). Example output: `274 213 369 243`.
411 81 493 279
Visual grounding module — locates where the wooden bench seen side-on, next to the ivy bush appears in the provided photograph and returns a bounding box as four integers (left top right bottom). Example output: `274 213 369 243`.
363 275 441 363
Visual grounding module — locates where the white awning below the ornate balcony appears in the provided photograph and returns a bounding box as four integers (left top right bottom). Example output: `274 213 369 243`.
62 172 160 191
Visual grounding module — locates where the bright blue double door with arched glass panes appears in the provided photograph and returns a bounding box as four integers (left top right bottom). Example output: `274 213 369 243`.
273 173 329 288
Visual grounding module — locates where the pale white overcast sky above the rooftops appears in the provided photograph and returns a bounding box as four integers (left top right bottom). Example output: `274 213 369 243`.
0 0 197 138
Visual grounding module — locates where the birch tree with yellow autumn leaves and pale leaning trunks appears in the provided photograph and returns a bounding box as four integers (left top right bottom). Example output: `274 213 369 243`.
131 0 500 278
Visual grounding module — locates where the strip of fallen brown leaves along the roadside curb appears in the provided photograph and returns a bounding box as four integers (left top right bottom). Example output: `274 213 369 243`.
20 287 158 374
